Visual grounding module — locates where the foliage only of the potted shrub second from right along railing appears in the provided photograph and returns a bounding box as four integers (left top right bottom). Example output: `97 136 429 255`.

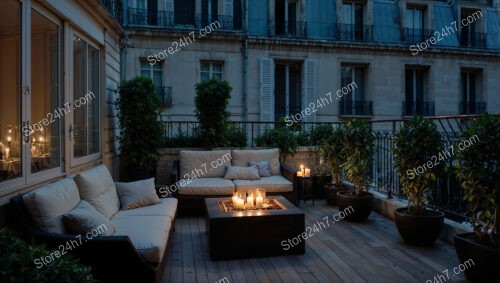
392 116 444 215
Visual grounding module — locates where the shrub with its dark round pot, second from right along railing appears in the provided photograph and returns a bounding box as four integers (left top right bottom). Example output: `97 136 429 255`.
392 116 449 246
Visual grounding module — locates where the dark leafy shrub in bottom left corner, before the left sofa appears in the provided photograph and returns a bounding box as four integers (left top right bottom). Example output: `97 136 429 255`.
0 228 96 283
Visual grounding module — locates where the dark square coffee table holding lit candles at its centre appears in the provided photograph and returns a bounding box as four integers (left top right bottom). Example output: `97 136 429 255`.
205 196 306 260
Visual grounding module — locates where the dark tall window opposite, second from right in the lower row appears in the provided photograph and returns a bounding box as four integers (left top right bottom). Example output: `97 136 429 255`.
403 68 434 116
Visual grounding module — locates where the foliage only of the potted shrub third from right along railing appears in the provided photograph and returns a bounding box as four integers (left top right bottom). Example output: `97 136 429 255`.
342 119 374 195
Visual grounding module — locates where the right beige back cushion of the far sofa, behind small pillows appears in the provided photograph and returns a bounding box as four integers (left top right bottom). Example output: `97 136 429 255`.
231 148 280 176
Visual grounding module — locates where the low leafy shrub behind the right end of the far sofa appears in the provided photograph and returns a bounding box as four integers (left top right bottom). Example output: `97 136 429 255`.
255 127 298 161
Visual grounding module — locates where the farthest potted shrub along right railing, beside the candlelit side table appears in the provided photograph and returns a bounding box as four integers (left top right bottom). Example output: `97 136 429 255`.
316 124 348 205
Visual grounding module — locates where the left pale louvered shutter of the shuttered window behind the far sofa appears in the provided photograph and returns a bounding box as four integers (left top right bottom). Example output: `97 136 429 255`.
260 58 274 130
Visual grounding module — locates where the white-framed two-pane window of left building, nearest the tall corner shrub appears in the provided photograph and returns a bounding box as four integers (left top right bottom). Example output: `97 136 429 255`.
70 34 101 165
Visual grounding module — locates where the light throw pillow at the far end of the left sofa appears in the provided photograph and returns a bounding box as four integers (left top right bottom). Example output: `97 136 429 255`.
116 178 160 210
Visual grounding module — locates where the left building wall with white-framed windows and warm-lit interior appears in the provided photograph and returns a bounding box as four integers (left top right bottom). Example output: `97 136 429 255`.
0 0 124 211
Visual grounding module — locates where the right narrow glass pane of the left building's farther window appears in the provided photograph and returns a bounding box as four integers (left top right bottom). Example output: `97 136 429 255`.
87 46 101 154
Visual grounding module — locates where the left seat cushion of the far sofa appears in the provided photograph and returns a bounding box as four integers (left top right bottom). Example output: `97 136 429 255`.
178 178 234 196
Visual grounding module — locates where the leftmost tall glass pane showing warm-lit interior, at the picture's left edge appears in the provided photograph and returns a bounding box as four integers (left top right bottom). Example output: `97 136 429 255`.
0 0 21 182
